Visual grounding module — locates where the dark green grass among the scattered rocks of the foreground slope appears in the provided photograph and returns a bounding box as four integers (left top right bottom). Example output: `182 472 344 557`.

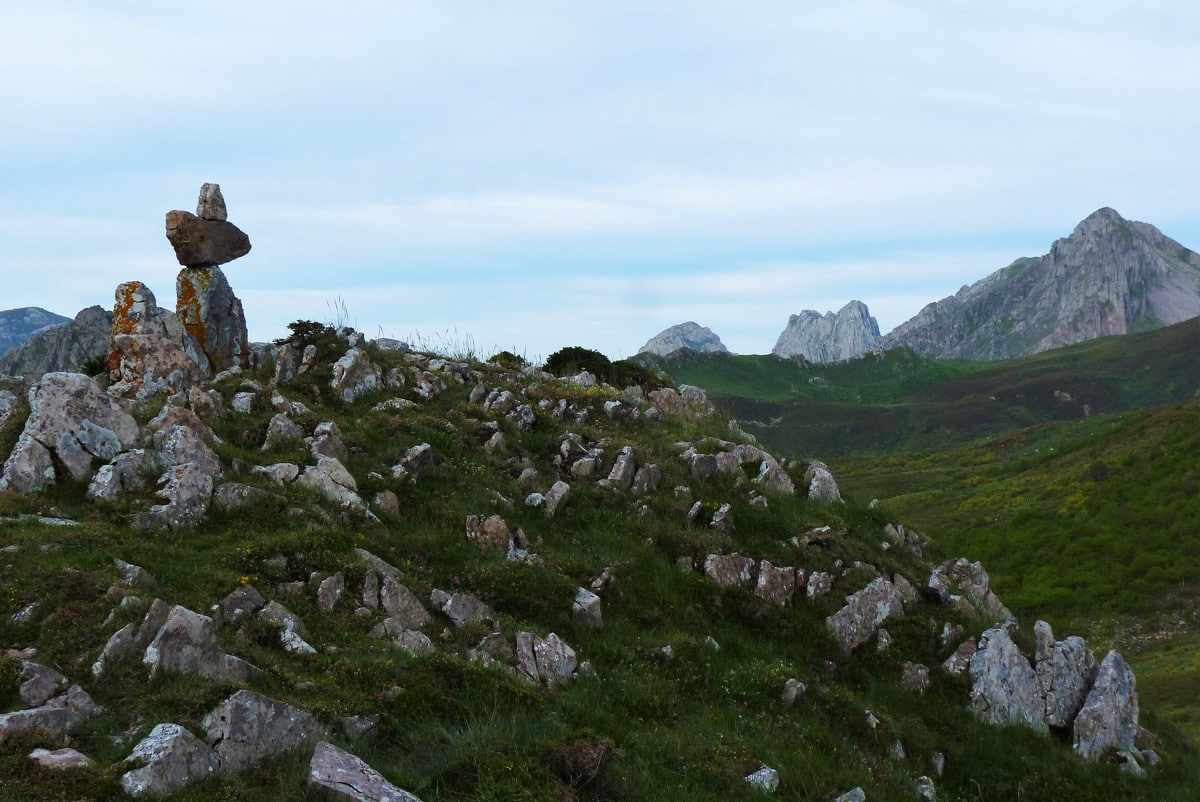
0 336 1200 802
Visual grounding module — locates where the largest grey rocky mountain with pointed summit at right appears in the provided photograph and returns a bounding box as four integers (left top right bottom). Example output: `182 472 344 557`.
881 209 1200 359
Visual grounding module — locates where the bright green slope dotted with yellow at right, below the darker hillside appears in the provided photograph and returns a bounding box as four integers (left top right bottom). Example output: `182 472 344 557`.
834 401 1200 743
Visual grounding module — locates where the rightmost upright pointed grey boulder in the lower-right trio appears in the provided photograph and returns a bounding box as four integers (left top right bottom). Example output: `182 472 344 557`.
1074 652 1138 760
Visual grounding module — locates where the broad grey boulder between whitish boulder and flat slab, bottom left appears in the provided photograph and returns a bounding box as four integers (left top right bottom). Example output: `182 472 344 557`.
203 690 326 773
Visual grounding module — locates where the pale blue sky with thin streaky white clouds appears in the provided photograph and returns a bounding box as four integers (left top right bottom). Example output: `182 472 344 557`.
0 0 1200 360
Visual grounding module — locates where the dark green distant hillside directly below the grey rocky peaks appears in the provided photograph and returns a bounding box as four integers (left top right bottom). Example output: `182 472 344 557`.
660 318 1200 457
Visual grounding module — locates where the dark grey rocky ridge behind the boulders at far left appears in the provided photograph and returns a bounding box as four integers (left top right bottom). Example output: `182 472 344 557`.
0 306 112 381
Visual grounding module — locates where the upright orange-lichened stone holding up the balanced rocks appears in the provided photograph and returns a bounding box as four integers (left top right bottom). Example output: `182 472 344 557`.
175 267 250 373
